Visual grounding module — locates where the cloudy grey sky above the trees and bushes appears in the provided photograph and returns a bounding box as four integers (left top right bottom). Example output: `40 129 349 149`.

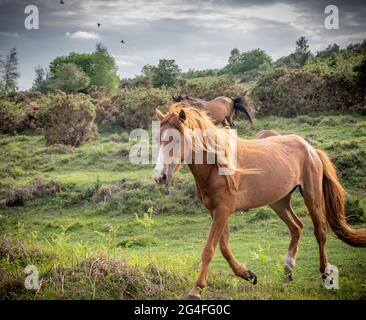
0 0 366 89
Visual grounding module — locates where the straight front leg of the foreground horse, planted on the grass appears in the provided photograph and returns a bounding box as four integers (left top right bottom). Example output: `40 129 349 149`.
188 207 230 299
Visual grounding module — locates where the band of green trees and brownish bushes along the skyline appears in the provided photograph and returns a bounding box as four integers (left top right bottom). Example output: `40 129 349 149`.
0 37 366 144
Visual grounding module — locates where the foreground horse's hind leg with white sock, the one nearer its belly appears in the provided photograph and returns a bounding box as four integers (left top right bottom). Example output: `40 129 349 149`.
270 193 303 280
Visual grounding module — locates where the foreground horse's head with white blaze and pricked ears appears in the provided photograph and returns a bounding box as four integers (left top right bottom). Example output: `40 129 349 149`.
153 109 186 184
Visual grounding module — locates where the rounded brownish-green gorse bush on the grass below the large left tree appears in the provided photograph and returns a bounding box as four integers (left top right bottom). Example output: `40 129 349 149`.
41 91 97 147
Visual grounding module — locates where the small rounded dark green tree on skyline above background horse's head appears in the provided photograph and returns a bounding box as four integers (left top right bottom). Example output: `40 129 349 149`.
151 59 180 88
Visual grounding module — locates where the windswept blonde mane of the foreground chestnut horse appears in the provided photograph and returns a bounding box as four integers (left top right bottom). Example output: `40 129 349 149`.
161 101 254 192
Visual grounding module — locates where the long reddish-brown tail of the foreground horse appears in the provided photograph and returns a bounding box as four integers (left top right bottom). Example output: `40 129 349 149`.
316 150 366 247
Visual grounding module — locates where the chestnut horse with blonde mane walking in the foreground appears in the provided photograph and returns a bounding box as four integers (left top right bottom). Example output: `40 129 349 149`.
153 103 366 299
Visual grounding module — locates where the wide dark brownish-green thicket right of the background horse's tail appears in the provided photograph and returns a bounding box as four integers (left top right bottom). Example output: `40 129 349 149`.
251 66 364 117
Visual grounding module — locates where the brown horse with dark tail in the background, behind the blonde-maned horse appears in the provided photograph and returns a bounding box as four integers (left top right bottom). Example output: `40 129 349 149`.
172 96 253 128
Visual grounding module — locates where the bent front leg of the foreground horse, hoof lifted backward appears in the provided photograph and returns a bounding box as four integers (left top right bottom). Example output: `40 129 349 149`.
220 224 257 284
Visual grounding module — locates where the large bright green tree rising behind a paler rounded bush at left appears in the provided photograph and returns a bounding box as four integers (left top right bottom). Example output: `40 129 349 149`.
50 43 120 93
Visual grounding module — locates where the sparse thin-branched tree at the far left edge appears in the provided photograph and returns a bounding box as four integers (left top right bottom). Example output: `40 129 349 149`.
0 48 20 92
